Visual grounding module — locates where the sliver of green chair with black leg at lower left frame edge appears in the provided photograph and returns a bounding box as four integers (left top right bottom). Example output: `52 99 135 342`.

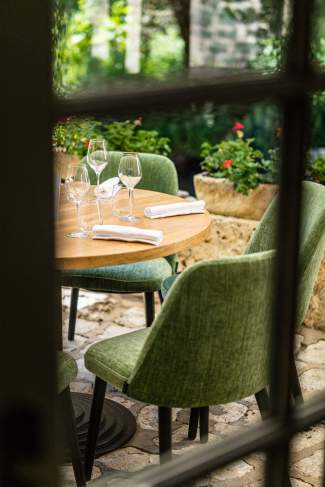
57 352 86 487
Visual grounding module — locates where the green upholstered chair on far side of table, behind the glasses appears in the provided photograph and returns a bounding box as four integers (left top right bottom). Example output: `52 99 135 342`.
61 152 178 340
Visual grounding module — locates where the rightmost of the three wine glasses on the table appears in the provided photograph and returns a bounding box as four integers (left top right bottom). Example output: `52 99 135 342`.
118 152 142 222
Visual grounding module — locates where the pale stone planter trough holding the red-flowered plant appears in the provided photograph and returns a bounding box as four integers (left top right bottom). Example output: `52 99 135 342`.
194 173 278 220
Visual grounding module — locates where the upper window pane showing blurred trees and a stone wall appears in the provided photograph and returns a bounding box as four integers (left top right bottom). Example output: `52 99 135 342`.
54 0 289 94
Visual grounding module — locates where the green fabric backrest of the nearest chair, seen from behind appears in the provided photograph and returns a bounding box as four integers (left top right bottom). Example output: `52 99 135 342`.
128 251 274 407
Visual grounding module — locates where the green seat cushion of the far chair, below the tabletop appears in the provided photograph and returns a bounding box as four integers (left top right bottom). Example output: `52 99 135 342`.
61 258 172 293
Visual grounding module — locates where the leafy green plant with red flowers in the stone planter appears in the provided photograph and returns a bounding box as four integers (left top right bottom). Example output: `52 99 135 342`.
201 122 262 194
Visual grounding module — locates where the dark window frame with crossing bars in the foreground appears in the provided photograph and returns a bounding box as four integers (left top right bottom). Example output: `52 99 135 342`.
0 0 325 487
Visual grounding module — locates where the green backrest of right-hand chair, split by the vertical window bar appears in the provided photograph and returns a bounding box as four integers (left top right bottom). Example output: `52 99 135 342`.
245 181 325 325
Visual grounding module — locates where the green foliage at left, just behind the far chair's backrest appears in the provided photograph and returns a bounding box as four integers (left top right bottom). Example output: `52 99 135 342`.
53 118 171 157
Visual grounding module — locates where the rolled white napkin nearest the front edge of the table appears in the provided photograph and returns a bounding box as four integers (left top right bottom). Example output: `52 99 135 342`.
93 225 163 245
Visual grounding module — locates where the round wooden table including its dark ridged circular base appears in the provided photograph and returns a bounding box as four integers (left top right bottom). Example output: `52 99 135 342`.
56 189 211 462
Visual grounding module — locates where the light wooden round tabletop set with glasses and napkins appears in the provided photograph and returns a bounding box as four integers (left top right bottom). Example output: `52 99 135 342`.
56 189 211 269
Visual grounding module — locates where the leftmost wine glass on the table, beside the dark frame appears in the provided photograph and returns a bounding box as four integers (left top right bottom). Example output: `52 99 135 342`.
65 164 90 238
